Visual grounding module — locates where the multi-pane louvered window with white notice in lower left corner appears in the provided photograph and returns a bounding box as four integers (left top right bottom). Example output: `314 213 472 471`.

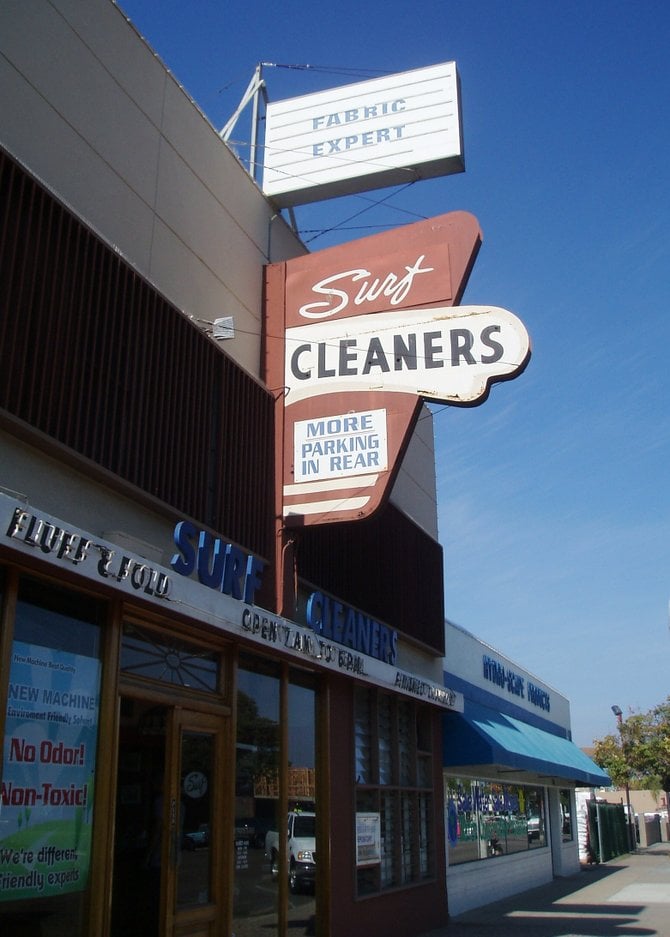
354 688 435 896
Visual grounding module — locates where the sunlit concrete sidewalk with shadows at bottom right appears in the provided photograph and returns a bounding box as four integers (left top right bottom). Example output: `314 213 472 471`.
423 843 670 937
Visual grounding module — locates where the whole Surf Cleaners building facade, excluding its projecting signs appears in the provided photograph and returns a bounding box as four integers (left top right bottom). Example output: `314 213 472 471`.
0 0 461 937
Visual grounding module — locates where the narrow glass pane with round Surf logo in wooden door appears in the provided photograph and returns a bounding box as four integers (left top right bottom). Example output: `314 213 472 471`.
177 730 214 906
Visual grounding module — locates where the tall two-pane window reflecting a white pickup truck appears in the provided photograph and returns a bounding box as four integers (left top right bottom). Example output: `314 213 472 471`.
233 657 317 937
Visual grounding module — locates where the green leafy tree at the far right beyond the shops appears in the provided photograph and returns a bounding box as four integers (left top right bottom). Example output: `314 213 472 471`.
594 696 670 803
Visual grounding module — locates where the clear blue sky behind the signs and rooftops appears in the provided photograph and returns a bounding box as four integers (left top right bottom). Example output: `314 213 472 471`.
120 0 670 745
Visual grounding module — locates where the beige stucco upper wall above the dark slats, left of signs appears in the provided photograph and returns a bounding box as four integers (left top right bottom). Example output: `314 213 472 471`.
0 0 305 375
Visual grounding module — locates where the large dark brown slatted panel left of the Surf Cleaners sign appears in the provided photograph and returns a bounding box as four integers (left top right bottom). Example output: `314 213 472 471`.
0 146 274 557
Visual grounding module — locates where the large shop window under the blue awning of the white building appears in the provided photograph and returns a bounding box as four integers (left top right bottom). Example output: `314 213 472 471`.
445 778 547 865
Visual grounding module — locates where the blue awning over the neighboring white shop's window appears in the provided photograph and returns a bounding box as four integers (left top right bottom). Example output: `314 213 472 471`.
443 700 612 787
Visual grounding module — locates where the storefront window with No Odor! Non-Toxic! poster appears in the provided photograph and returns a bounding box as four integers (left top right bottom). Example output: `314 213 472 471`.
0 578 105 937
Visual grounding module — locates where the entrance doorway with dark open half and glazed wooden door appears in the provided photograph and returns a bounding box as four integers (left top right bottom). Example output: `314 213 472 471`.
111 699 229 937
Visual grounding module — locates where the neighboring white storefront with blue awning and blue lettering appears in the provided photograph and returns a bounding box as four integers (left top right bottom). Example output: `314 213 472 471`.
443 622 609 915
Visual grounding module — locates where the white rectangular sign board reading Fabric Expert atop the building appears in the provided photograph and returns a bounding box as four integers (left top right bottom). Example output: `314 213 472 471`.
263 62 465 208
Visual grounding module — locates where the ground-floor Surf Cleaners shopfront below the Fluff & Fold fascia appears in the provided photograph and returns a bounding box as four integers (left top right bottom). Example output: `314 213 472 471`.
0 494 461 937
